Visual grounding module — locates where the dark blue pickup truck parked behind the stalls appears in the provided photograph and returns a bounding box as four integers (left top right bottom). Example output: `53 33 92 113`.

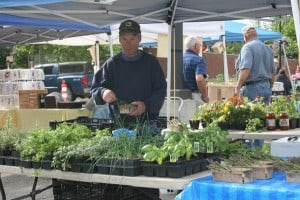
34 62 94 100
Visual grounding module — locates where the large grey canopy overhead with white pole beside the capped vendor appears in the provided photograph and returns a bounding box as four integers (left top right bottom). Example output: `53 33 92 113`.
0 0 300 118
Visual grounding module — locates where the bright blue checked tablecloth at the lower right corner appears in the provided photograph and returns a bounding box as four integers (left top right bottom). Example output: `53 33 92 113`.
175 172 300 200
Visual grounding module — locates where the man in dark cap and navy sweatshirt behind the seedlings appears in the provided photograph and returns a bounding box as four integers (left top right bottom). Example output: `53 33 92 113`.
91 20 166 130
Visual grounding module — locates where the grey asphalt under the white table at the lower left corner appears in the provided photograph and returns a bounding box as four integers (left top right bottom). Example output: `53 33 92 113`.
0 173 54 200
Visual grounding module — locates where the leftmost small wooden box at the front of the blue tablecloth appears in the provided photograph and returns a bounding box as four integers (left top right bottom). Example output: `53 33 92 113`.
212 168 253 183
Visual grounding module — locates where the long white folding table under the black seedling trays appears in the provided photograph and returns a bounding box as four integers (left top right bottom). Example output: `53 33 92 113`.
0 165 211 199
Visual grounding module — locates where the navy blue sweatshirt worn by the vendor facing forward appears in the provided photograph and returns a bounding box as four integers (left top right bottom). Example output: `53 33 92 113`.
91 52 167 119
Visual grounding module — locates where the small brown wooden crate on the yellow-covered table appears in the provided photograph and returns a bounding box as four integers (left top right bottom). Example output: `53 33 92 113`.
19 89 48 109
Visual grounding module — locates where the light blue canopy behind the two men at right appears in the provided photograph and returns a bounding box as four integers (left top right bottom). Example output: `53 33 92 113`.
203 21 282 43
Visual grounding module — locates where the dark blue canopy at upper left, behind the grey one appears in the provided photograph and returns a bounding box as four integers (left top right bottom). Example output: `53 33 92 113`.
0 14 111 46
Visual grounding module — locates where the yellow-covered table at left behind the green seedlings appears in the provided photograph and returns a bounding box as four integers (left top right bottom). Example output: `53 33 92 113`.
0 108 92 131
